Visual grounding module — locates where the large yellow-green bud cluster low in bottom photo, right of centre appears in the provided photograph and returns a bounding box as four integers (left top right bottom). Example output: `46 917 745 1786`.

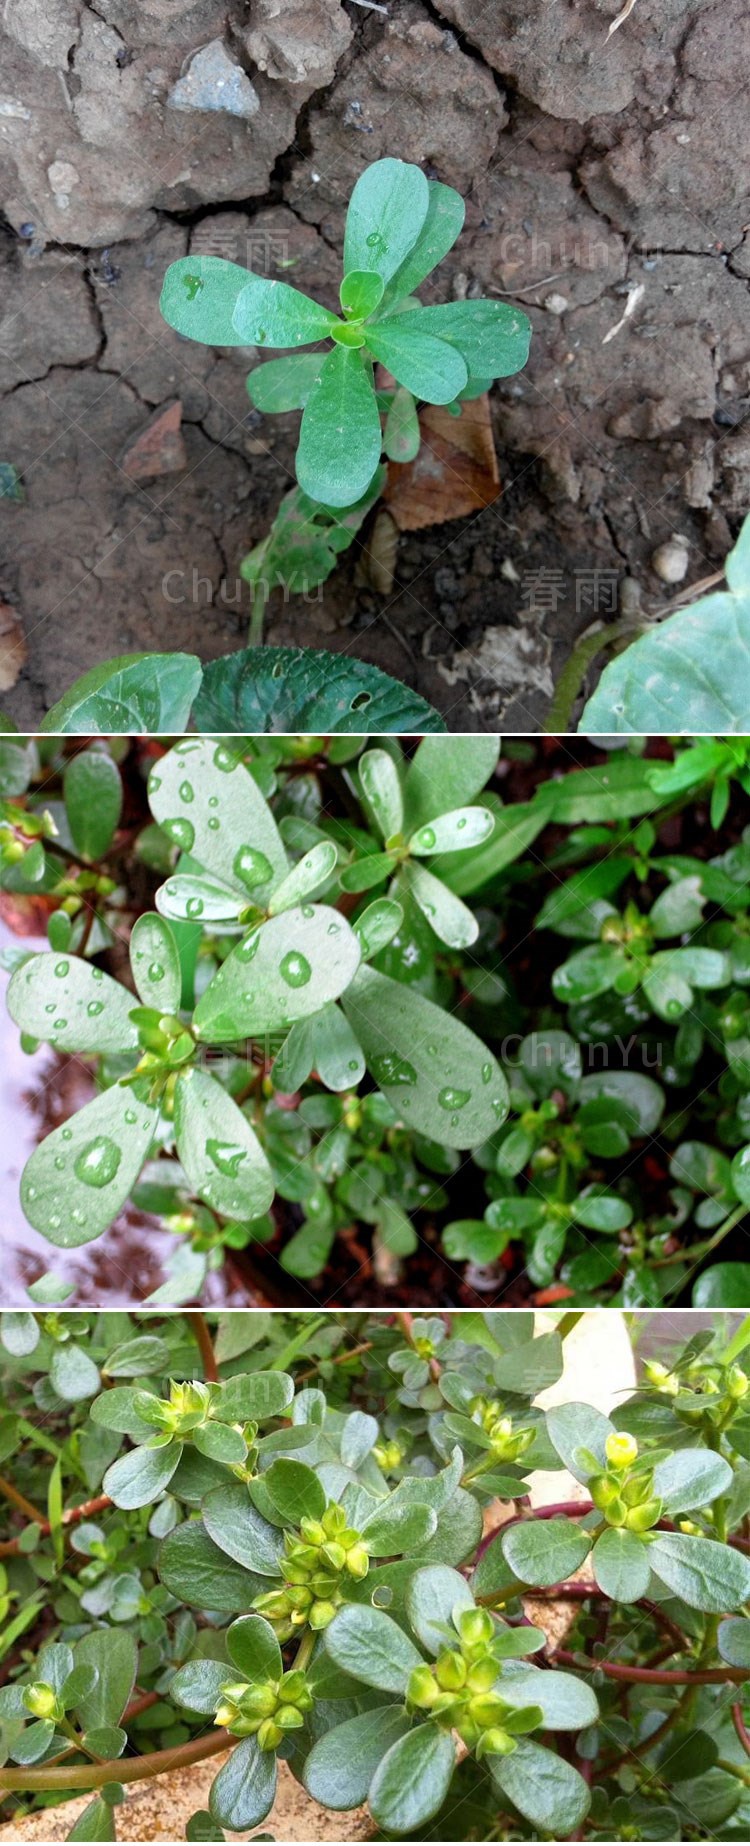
406 1610 541 1757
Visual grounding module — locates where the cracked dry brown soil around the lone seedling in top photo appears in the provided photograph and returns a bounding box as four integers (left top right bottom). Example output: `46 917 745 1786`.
0 0 750 731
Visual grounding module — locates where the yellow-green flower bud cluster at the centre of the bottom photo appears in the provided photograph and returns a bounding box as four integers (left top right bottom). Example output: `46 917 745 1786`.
253 1504 369 1641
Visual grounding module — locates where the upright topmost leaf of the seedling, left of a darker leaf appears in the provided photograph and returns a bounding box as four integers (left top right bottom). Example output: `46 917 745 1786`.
344 159 430 282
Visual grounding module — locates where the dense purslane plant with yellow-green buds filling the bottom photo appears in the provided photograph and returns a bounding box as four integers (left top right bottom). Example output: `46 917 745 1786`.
0 1311 750 1840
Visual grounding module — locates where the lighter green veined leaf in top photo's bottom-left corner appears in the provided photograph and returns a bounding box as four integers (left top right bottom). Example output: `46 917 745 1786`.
41 653 201 737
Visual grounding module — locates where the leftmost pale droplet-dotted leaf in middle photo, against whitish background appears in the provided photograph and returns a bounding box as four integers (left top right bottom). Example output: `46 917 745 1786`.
7 951 139 1052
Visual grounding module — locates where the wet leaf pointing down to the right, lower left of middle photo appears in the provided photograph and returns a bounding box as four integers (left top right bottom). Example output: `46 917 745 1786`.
174 1069 273 1220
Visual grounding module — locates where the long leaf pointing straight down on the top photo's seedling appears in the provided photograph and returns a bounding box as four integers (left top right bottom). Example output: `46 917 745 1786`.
297 345 382 506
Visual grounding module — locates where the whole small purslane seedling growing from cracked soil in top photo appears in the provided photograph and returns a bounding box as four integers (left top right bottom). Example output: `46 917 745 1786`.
161 159 530 508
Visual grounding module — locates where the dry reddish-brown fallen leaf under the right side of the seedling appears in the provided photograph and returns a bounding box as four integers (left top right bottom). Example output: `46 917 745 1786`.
382 393 501 532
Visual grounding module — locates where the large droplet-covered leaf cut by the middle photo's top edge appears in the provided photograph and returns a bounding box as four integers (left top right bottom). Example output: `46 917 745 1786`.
148 737 288 903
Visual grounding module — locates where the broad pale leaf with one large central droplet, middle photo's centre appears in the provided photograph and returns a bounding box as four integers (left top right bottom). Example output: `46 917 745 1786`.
194 905 360 1043
